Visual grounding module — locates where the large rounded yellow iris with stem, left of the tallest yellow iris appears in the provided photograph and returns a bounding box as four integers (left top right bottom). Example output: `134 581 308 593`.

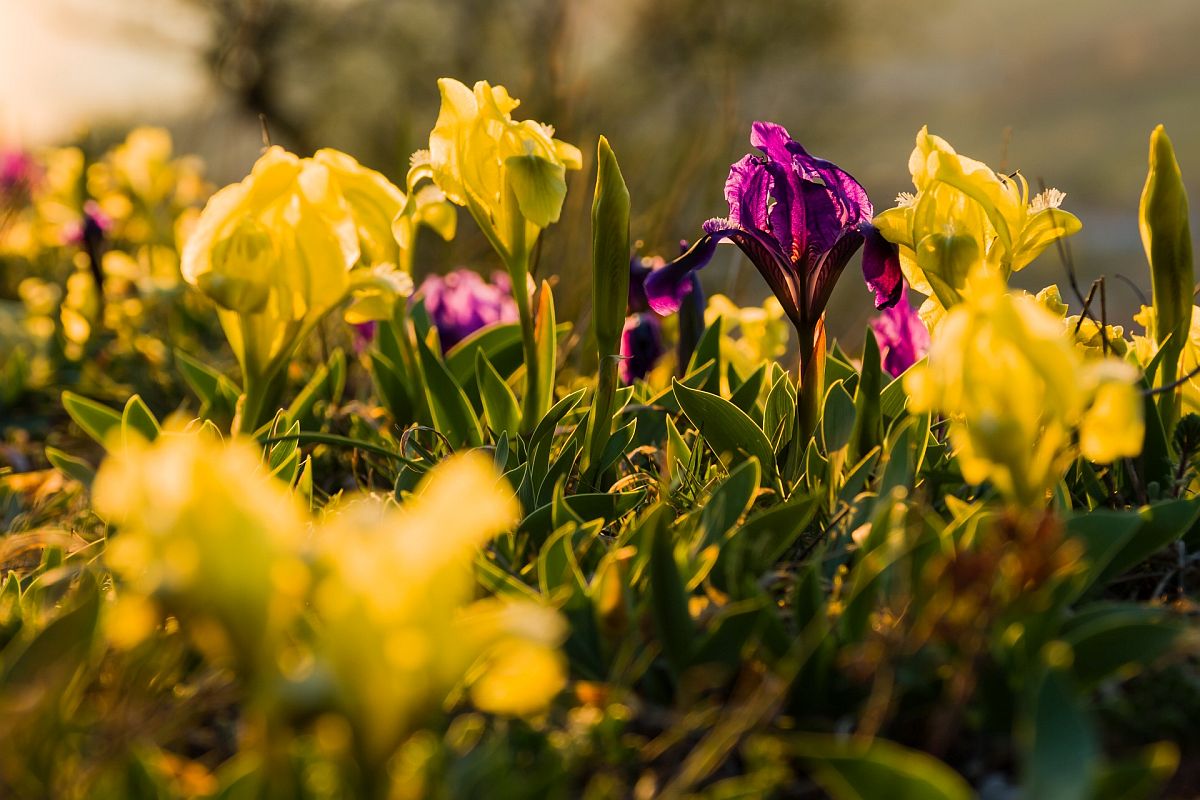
181 146 441 427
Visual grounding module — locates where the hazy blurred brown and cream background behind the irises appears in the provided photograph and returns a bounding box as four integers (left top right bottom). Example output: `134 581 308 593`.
0 0 1200 342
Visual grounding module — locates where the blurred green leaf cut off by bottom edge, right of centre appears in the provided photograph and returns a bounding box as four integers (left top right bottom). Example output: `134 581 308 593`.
781 734 974 800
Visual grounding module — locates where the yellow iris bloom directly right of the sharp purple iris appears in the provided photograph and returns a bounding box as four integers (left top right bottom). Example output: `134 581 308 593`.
875 127 1081 321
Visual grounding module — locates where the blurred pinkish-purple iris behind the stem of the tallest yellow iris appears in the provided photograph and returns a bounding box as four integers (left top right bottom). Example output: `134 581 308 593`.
414 270 517 350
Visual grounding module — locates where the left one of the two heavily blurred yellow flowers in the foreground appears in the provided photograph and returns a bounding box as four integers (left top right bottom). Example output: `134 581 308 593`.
94 432 306 672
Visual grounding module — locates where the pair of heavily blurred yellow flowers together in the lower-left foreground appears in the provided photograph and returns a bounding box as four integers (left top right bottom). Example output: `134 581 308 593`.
95 433 565 764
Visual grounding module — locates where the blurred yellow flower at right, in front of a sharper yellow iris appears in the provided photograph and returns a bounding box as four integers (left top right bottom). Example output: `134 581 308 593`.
905 269 1145 507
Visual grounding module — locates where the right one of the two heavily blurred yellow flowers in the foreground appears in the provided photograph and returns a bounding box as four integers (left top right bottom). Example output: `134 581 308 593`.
316 453 565 763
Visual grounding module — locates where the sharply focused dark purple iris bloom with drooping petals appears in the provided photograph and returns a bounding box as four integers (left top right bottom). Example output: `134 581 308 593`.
646 122 901 331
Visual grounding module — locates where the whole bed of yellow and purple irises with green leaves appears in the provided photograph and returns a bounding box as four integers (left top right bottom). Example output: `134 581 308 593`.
7 79 1200 800
